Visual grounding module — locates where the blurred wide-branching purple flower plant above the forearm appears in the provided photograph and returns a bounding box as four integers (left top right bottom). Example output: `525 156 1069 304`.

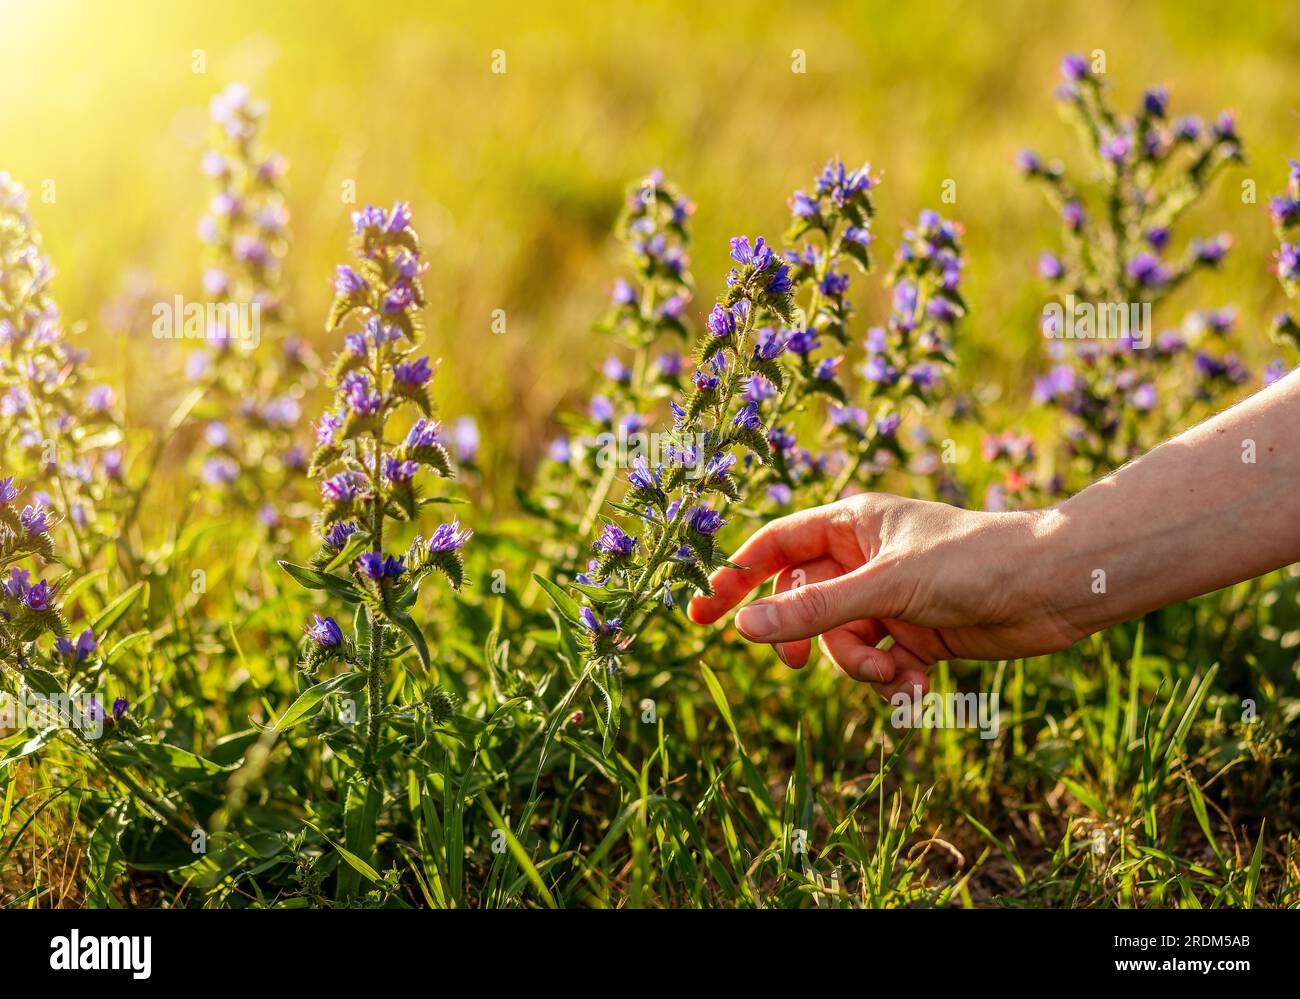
1019 56 1249 488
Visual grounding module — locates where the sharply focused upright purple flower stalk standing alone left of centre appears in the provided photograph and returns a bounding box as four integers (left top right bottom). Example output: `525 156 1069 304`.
286 203 469 775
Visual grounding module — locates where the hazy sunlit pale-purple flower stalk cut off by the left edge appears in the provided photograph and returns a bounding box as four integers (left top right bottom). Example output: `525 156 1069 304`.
0 173 122 566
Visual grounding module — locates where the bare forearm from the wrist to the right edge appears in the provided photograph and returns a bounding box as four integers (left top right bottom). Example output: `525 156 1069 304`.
1027 372 1300 633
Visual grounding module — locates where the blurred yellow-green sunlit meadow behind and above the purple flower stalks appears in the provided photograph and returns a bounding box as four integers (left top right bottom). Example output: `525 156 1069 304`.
0 0 1300 496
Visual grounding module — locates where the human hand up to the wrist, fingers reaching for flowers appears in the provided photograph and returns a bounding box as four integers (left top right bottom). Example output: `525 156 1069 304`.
690 493 1082 697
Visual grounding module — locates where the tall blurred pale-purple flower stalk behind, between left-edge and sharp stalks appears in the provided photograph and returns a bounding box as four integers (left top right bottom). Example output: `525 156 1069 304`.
189 83 317 527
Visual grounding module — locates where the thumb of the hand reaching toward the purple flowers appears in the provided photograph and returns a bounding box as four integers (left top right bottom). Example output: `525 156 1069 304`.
736 566 896 644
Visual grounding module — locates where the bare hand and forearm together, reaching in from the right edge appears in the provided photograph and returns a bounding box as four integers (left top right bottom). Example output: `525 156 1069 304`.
690 371 1300 697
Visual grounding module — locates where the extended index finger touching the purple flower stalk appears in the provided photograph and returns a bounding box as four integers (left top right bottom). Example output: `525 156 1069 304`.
690 506 829 624
